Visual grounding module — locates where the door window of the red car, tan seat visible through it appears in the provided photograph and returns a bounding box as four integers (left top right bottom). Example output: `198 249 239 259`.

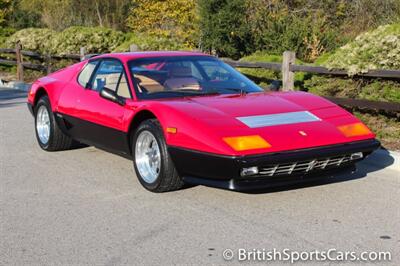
92 60 131 98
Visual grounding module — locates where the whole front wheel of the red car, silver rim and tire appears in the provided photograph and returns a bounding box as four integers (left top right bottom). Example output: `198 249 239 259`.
132 119 184 192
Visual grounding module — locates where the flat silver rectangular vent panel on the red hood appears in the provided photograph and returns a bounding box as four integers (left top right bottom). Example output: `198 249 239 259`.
236 111 321 128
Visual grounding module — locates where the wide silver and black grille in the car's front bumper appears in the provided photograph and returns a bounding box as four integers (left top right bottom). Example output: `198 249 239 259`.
257 154 362 176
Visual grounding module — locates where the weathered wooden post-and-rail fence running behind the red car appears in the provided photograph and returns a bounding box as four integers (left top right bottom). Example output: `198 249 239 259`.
0 43 400 117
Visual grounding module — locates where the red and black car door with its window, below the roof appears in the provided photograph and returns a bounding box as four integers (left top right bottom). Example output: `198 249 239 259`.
72 58 131 154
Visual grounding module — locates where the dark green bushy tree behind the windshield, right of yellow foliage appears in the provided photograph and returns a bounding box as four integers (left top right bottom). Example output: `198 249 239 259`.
199 0 253 58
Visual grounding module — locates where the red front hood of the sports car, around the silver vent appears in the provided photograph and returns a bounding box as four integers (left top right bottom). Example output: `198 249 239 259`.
157 92 374 155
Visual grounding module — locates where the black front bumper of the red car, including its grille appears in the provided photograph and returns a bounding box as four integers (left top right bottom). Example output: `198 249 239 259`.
168 139 380 190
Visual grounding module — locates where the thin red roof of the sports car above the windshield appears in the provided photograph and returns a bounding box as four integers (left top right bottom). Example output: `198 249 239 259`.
92 51 210 62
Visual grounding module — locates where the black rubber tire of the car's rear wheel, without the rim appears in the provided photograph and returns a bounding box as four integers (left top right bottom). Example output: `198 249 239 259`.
35 96 74 151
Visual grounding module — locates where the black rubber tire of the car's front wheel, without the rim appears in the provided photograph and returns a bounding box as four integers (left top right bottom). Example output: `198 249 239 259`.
132 119 185 193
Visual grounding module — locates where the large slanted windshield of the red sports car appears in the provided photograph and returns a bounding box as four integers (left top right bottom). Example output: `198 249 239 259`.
129 56 263 99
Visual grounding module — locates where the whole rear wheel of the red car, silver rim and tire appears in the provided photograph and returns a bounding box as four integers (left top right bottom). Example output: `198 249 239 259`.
35 96 73 151
